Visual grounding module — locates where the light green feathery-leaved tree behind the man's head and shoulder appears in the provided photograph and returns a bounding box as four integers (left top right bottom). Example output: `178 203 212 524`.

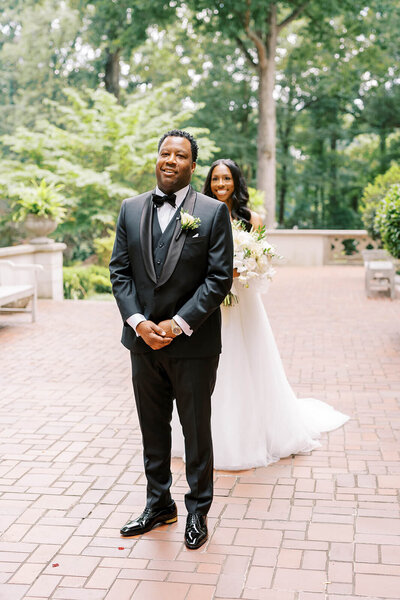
0 82 215 257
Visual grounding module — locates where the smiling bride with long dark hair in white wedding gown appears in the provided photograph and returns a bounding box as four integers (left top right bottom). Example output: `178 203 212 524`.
172 159 349 470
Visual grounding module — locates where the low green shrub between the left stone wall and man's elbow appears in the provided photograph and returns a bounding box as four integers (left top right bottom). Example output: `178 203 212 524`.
63 265 112 300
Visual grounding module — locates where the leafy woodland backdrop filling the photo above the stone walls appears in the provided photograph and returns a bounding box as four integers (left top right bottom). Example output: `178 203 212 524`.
0 0 400 247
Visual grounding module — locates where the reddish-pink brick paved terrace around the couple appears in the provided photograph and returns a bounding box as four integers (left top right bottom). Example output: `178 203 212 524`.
0 267 400 600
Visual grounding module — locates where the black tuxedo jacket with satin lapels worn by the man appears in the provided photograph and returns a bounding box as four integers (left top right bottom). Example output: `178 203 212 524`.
110 187 233 358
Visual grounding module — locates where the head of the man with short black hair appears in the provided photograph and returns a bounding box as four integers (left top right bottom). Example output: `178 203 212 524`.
156 136 196 194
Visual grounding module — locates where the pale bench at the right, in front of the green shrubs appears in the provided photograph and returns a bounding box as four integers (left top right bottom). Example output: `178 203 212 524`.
362 250 396 300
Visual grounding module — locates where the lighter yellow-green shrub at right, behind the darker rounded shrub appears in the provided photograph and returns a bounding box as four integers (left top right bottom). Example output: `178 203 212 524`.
360 164 400 240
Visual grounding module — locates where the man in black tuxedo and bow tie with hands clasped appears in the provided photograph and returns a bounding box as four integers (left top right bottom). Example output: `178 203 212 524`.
110 130 233 549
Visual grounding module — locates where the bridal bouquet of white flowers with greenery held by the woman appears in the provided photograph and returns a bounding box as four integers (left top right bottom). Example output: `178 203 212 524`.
224 221 277 306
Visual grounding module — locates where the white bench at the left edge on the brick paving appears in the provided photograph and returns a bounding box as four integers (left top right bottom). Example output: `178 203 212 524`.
0 260 43 323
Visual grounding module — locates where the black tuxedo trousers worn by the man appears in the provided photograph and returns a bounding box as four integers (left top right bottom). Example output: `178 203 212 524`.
131 352 219 515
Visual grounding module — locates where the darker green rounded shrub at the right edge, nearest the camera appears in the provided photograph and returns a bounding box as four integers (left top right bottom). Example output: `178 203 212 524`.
375 184 400 258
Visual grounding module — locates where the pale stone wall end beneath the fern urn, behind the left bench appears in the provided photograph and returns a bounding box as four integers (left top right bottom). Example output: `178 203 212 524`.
0 242 66 300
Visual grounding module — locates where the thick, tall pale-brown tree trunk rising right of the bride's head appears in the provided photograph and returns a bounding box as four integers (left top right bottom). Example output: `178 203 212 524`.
257 5 278 228
